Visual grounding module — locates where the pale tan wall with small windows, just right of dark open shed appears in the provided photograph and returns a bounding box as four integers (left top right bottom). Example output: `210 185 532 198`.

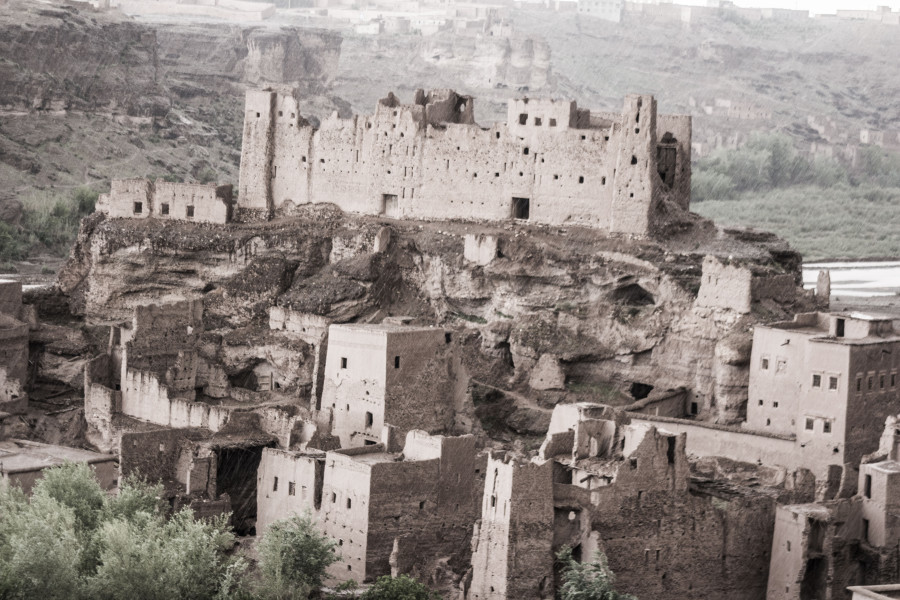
256 448 322 536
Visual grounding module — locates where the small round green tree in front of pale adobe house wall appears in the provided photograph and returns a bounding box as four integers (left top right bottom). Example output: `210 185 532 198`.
258 514 338 600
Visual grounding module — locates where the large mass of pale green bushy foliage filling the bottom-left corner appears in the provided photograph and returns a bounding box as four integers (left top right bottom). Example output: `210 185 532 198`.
0 464 246 600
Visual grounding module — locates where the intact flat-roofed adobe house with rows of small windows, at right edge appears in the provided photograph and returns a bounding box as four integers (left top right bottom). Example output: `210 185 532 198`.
744 312 900 472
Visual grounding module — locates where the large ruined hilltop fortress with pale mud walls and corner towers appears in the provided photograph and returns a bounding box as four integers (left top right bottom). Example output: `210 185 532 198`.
240 90 691 236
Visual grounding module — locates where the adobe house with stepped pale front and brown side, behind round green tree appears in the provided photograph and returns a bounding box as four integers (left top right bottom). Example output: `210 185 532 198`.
256 430 484 582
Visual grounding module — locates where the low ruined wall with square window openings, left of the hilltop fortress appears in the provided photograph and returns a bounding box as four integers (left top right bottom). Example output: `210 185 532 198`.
97 179 233 224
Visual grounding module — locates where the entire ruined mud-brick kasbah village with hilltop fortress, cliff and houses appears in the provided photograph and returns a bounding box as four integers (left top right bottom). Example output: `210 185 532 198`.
0 84 900 600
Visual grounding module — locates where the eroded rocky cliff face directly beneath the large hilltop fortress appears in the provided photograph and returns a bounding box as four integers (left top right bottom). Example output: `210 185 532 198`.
59 205 806 434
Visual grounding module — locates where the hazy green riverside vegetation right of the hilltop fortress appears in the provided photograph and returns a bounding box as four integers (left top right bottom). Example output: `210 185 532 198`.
691 134 900 259
